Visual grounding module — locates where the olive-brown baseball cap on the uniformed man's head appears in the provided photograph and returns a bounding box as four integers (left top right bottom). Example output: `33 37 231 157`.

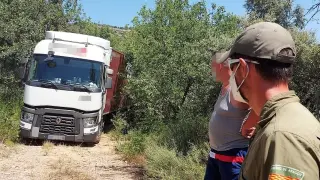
219 22 296 63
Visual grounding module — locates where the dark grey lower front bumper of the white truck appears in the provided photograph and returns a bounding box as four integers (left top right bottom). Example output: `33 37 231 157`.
20 107 102 142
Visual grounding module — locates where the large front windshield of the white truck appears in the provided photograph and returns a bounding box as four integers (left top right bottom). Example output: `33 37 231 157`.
28 54 102 92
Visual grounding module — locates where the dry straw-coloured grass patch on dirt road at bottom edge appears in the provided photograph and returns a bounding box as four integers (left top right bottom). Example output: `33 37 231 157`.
47 158 95 180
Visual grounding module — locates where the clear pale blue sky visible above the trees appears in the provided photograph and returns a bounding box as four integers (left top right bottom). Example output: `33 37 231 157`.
80 0 320 42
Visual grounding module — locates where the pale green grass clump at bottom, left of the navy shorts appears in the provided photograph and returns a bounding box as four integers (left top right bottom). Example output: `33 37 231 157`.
145 138 209 180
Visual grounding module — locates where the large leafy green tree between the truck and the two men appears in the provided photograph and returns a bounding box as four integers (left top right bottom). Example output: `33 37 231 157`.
125 0 240 152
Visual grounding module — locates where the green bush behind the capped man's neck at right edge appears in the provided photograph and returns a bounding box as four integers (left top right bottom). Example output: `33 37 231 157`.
291 31 320 119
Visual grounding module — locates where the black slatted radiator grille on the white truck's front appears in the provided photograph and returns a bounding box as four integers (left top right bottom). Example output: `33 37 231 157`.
40 115 79 135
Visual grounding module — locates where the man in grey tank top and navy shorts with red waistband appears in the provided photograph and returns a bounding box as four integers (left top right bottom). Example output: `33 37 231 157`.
204 53 259 180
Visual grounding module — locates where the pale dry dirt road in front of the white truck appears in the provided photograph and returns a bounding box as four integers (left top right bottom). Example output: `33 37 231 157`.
0 135 141 180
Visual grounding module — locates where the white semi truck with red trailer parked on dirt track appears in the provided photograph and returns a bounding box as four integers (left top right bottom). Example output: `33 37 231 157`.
20 31 125 144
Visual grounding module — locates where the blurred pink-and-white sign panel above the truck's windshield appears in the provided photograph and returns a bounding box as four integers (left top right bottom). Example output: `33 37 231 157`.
49 43 87 57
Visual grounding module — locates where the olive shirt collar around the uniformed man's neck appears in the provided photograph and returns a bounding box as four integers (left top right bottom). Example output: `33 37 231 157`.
258 91 300 129
